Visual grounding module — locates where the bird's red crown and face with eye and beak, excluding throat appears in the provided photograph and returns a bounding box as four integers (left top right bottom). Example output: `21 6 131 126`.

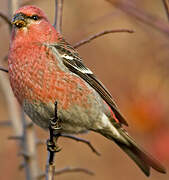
11 6 48 29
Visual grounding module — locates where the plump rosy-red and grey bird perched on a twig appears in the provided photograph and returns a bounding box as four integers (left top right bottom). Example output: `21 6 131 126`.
8 5 166 176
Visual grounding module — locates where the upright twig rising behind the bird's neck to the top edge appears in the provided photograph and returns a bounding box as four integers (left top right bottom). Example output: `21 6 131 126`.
54 0 63 33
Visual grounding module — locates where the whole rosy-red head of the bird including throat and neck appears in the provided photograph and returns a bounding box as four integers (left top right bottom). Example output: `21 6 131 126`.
11 6 59 44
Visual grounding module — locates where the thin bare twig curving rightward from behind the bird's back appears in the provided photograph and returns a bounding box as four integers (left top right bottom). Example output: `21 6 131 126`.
73 29 134 48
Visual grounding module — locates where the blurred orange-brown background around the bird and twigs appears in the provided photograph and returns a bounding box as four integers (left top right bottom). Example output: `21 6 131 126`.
0 0 169 180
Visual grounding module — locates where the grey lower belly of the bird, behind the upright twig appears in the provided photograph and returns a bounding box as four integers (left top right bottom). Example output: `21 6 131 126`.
23 98 102 134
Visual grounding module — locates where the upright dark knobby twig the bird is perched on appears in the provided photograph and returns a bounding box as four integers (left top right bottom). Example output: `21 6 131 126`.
46 102 61 180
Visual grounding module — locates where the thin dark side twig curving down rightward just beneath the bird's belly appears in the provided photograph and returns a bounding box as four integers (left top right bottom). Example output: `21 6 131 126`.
60 134 100 156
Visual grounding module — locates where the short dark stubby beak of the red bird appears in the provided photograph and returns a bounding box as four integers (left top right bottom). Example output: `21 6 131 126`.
11 13 27 28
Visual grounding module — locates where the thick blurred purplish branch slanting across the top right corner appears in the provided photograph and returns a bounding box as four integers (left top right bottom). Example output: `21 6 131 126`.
109 0 169 35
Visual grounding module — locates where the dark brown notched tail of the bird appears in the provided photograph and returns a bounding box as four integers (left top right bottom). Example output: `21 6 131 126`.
103 128 166 176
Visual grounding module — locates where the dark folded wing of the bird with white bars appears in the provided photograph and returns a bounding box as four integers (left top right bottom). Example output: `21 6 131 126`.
47 39 128 126
